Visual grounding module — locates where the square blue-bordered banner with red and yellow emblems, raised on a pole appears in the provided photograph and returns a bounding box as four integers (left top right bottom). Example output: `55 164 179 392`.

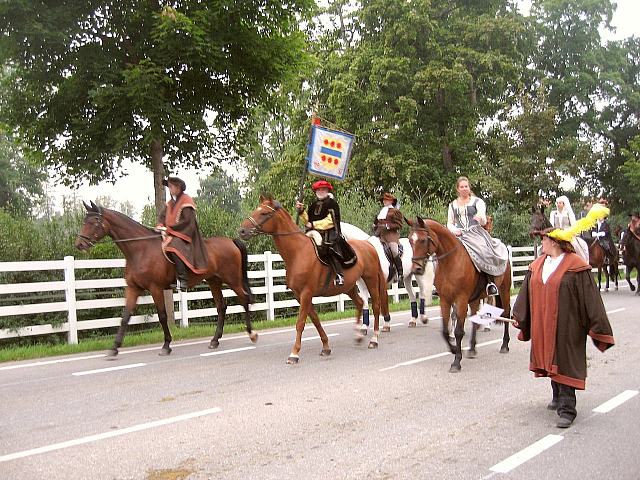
307 125 354 180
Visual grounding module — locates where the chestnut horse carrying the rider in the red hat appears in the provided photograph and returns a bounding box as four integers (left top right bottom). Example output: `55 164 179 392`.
240 196 389 364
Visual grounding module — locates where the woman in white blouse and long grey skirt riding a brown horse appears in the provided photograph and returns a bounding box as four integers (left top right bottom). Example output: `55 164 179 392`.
447 177 509 296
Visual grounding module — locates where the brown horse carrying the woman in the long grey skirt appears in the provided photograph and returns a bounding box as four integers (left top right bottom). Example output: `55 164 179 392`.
409 218 511 372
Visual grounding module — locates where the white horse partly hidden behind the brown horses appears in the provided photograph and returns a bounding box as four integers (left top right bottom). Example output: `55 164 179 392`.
340 222 435 334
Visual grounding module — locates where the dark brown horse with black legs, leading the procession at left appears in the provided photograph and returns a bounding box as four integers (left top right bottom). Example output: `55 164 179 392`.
75 202 258 356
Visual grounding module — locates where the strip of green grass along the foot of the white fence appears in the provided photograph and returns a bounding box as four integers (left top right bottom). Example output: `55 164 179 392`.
0 300 418 362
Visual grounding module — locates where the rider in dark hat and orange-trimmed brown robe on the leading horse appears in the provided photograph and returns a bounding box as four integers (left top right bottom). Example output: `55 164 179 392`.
156 177 208 290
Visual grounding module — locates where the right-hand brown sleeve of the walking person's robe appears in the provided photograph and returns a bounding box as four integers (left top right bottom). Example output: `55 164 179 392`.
576 270 615 352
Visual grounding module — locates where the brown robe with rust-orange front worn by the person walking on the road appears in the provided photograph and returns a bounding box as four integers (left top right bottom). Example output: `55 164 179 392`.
512 253 615 390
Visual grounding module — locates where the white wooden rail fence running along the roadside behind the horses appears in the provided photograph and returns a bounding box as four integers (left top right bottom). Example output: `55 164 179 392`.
0 247 620 343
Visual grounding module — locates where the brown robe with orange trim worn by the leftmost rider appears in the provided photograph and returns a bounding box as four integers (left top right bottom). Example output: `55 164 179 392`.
158 193 208 275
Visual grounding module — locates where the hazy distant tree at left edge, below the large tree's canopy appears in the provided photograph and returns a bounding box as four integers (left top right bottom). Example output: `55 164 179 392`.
0 133 46 216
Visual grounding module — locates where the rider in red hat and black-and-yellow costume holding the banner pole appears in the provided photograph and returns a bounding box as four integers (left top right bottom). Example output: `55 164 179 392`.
296 180 344 285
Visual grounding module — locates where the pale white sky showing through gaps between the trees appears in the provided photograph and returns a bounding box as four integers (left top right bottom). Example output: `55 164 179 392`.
48 0 640 219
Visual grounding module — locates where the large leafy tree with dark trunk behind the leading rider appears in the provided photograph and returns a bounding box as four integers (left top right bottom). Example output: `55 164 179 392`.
0 0 314 212
